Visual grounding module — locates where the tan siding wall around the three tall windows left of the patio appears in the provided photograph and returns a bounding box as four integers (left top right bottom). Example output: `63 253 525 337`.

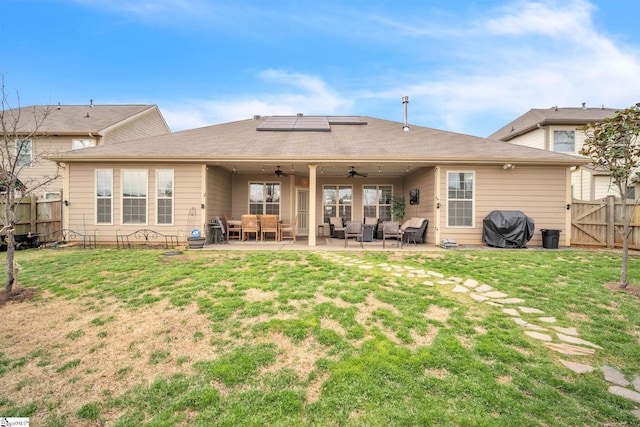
65 163 206 242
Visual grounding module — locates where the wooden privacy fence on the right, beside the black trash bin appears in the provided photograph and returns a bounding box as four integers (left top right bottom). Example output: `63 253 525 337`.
571 196 640 249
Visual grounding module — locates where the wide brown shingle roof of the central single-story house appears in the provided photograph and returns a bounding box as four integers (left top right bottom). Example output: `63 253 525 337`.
51 116 588 169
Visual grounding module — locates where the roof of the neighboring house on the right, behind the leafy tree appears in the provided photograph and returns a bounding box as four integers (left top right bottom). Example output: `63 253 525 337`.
488 107 620 141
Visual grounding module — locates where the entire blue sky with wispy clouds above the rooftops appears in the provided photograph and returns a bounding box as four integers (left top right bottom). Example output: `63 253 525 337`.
0 0 640 136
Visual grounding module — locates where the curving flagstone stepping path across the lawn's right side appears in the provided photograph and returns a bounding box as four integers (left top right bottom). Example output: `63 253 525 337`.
323 252 640 412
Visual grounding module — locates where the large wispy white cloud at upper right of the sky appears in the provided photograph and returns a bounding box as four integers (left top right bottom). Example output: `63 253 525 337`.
364 1 640 136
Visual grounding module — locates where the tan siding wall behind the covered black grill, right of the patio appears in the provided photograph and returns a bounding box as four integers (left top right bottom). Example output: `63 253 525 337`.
439 166 570 246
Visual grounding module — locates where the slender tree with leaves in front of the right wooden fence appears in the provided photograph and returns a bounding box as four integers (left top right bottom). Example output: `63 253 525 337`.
580 103 640 288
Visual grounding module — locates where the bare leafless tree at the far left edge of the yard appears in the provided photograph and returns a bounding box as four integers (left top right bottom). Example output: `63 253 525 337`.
0 74 60 292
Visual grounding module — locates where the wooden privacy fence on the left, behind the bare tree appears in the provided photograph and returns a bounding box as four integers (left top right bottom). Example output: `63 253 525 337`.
0 197 62 234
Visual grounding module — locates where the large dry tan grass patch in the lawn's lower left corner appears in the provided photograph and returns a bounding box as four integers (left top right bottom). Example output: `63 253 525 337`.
2 299 216 420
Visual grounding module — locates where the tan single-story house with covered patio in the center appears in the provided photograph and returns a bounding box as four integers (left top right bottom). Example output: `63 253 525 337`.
51 114 588 246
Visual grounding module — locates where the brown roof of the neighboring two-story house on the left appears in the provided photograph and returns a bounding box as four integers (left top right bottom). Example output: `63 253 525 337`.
5 105 169 136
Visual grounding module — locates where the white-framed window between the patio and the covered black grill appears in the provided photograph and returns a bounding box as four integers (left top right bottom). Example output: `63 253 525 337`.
447 172 475 227
